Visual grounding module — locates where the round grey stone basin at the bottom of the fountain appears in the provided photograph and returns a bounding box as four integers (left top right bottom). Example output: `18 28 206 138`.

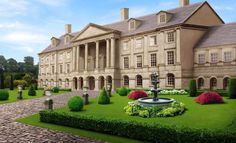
138 97 175 107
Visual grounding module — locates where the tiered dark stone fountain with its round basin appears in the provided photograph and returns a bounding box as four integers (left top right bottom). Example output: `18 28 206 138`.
138 72 174 107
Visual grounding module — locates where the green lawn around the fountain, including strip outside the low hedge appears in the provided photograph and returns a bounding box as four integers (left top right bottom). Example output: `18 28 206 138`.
18 95 236 142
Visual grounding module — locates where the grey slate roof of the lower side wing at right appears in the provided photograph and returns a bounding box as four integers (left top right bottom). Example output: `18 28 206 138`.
196 23 236 48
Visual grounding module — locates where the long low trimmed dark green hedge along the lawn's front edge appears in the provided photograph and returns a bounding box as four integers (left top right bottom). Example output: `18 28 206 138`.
39 110 236 143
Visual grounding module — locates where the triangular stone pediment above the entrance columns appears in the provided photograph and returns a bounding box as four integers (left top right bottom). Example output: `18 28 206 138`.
74 23 113 41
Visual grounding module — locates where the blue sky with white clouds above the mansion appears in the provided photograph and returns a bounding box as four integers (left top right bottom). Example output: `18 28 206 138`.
0 0 236 62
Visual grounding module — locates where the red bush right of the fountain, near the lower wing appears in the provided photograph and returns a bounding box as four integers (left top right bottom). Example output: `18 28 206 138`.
195 92 224 104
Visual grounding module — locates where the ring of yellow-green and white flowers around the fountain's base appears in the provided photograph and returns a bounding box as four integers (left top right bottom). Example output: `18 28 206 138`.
124 101 186 118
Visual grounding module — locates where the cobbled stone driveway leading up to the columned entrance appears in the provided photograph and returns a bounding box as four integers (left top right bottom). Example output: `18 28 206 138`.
0 91 104 143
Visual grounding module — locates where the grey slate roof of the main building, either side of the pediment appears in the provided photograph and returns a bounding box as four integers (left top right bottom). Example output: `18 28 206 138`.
41 2 204 53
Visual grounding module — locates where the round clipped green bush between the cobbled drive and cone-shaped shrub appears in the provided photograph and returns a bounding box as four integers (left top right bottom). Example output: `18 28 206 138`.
68 96 84 111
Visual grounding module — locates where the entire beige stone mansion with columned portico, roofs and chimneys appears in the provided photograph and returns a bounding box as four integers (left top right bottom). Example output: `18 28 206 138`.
38 0 236 90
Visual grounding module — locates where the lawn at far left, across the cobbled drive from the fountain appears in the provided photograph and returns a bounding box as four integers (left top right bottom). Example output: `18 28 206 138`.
0 89 65 104
